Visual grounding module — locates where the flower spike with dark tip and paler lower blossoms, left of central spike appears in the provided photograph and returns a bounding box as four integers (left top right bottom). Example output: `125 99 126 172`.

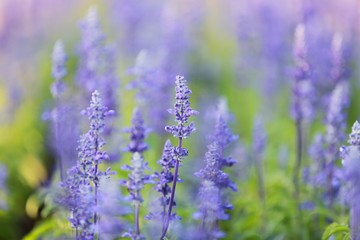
120 109 153 239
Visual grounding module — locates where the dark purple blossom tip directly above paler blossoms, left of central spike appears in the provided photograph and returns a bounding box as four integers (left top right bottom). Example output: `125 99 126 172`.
127 108 149 154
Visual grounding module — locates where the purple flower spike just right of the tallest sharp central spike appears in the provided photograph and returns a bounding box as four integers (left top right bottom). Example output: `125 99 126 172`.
194 115 238 239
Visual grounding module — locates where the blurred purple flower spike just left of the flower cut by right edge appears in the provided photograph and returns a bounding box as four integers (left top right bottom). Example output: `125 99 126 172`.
310 53 349 207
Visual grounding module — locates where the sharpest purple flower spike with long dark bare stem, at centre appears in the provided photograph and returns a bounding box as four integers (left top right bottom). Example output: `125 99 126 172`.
160 76 198 239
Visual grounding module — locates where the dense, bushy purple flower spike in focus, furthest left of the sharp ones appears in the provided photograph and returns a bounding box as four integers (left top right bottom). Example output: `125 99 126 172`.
59 91 113 239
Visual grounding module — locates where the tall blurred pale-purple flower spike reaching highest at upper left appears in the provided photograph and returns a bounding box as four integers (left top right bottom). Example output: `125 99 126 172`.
76 7 119 141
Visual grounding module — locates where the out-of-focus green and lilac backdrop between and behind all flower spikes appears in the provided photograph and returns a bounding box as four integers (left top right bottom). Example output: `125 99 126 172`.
0 0 360 240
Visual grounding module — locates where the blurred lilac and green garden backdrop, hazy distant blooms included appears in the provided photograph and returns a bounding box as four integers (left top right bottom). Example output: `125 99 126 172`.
0 0 360 240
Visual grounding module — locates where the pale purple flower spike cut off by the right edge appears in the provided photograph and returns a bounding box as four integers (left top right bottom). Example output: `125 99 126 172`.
341 121 360 240
